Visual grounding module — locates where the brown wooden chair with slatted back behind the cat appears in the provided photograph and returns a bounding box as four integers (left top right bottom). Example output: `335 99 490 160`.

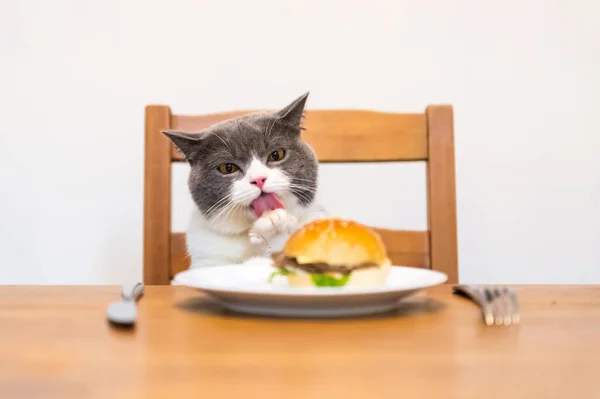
144 105 458 284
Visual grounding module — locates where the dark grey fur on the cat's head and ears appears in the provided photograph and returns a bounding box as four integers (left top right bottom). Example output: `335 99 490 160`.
163 93 318 219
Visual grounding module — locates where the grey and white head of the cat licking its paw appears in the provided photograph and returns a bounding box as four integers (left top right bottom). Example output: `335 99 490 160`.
163 93 318 228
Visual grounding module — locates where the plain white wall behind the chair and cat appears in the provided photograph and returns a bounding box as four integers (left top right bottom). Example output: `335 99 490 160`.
0 0 600 284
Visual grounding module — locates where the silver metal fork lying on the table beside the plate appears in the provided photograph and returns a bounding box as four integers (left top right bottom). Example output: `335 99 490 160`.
452 285 521 326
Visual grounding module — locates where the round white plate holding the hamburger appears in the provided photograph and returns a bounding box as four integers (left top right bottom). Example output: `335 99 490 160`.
173 265 447 317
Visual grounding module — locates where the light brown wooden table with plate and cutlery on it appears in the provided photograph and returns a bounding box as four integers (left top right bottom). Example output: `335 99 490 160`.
0 286 600 399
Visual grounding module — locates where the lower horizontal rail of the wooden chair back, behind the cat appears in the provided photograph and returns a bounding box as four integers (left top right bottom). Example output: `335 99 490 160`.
170 228 430 277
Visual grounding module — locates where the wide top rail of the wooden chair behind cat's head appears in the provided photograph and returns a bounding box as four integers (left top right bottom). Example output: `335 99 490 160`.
171 110 427 162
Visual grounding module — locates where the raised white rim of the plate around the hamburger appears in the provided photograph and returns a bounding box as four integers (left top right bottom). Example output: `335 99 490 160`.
172 264 448 297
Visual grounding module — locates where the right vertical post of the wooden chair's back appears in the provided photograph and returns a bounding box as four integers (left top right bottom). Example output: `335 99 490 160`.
426 105 458 283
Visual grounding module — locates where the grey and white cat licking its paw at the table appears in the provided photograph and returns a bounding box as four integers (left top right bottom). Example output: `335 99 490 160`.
163 93 326 268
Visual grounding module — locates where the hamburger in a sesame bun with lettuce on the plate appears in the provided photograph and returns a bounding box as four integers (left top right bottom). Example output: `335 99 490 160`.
271 218 391 287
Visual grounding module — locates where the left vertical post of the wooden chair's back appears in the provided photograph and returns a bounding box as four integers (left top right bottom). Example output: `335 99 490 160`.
144 105 171 285
